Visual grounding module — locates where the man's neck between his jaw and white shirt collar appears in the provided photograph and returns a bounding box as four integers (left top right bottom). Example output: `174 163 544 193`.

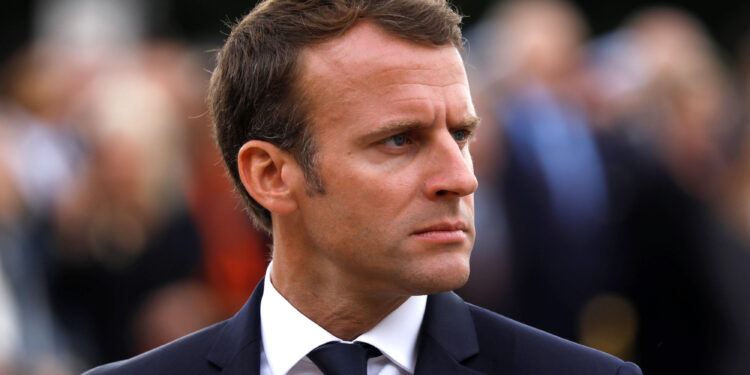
271 239 408 341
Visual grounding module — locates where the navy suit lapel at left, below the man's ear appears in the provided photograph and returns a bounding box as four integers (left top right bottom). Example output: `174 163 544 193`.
206 280 263 375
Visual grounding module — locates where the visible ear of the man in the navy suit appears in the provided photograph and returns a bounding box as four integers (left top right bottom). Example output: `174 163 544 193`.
237 140 301 215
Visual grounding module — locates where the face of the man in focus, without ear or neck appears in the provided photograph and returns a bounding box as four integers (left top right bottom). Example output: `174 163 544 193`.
295 22 478 295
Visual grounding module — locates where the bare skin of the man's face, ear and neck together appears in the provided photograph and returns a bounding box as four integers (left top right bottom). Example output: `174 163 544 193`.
239 21 478 340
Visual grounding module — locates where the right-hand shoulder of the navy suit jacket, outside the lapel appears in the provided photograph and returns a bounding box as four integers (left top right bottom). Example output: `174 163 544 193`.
467 303 641 375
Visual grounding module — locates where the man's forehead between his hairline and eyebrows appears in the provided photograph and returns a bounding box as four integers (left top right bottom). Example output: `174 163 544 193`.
301 21 467 104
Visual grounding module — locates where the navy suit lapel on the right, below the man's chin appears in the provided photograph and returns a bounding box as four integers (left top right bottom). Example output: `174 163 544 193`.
414 292 481 375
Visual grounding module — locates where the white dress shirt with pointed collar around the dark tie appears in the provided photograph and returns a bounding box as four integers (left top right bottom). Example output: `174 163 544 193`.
260 265 427 375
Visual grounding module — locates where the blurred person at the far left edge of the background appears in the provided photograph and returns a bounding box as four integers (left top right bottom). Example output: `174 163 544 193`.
0 44 90 374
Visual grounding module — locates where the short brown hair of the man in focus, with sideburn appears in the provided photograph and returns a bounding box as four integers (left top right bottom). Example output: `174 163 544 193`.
208 0 461 232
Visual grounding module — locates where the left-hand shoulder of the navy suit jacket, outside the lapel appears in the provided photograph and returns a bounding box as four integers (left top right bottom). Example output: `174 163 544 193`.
83 321 227 375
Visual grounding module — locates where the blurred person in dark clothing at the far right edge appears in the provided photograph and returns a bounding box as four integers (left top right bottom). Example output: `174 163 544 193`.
589 8 750 374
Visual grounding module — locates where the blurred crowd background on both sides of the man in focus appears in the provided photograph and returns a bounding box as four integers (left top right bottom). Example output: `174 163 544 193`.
0 0 750 375
